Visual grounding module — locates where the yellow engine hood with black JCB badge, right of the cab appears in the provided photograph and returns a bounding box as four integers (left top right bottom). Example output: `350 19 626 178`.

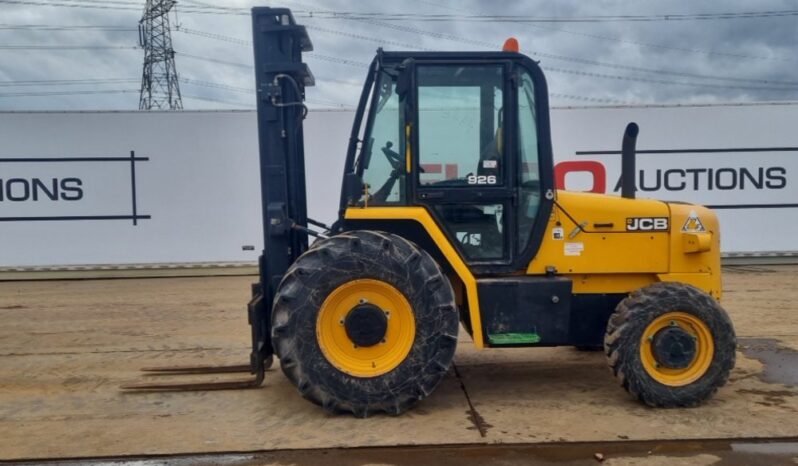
526 191 721 300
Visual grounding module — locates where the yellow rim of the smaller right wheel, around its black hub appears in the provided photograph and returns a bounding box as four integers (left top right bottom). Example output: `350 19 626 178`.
640 312 715 387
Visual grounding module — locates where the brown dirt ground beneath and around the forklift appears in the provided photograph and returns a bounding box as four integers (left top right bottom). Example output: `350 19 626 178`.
0 266 798 464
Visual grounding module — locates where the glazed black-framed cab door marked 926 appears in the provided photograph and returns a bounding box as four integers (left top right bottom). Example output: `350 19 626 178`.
413 61 517 266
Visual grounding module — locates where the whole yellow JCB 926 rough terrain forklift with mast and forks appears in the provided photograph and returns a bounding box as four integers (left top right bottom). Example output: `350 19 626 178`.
123 8 736 417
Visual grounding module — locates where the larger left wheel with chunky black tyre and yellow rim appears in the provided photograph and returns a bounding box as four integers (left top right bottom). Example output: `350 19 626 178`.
272 231 459 417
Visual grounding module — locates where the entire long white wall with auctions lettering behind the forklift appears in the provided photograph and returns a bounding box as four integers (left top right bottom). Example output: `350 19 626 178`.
0 104 798 267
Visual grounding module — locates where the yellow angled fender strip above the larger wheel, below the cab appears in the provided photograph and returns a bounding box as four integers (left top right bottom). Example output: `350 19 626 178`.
344 207 485 348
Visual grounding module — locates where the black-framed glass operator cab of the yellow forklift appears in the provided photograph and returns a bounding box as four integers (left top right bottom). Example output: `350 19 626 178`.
341 46 554 271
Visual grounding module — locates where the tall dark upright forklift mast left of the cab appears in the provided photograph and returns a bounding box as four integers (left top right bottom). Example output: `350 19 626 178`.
248 7 314 374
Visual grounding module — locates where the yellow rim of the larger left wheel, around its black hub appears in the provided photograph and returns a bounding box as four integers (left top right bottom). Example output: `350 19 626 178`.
316 279 416 377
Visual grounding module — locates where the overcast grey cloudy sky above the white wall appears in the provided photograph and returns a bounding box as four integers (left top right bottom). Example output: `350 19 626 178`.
0 0 798 110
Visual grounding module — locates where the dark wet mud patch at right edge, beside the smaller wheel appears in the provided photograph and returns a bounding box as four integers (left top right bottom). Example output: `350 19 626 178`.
739 338 798 387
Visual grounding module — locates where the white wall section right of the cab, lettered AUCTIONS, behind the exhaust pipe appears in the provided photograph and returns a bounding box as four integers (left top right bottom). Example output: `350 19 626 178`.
552 104 798 253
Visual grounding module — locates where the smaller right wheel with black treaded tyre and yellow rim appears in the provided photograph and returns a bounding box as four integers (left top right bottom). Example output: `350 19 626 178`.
604 282 737 408
